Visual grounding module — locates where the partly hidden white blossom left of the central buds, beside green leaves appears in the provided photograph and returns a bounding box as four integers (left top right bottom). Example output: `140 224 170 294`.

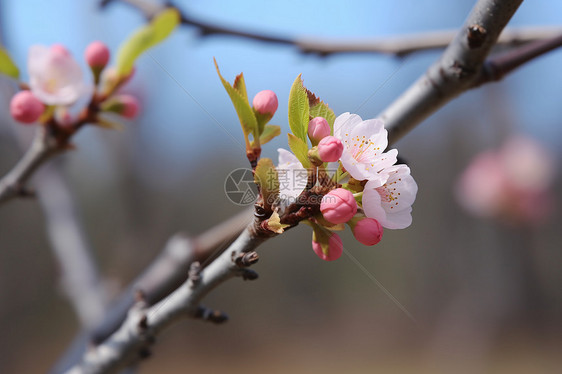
277 148 308 205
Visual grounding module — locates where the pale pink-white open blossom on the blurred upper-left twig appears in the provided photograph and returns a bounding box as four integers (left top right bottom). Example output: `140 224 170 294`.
27 45 90 105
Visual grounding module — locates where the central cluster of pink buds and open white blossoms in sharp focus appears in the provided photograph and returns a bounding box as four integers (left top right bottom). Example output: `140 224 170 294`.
279 113 417 261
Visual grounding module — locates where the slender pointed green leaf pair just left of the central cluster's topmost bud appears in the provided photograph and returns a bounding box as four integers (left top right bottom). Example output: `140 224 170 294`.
214 60 260 139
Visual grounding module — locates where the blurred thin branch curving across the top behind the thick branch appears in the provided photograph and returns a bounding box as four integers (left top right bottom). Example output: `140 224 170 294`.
100 0 562 56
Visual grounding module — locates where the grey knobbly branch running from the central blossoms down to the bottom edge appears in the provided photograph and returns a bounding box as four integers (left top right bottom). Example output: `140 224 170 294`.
67 220 272 374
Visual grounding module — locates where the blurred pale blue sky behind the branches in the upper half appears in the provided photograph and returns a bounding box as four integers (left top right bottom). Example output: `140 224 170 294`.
0 0 562 173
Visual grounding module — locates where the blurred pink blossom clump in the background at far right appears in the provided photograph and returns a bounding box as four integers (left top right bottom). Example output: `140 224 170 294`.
455 135 556 225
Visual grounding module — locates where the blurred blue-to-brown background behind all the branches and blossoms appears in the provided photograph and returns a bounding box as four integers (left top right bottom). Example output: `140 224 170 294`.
0 0 562 373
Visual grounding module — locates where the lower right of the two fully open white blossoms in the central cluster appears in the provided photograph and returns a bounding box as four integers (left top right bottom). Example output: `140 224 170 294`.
362 165 418 229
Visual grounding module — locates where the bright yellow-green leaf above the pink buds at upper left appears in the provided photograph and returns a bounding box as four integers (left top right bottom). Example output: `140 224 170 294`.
117 8 180 76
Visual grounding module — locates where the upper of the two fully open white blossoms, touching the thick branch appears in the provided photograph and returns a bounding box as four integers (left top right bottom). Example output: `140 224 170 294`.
334 113 398 183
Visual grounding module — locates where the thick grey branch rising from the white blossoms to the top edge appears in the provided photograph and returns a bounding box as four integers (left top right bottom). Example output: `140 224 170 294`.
379 0 523 143
